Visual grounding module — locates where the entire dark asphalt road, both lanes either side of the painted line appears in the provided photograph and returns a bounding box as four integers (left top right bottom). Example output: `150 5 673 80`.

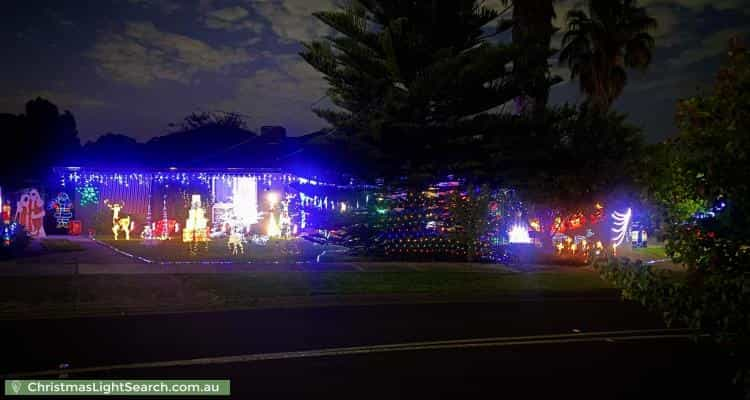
0 296 735 399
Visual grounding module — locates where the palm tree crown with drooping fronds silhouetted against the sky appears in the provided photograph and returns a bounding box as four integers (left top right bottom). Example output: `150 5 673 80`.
560 0 657 111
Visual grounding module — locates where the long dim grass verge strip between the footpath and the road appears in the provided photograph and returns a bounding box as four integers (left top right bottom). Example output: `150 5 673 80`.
0 270 611 319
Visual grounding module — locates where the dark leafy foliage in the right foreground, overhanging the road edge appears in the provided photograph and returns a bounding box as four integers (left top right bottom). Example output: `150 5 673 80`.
605 40 750 395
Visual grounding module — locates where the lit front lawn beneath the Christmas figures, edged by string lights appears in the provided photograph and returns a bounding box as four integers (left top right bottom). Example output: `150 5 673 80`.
100 239 362 262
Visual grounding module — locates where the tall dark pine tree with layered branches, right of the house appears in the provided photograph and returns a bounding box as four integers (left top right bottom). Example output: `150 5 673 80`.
301 0 552 184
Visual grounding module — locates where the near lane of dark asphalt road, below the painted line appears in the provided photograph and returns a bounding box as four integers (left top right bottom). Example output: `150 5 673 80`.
87 340 741 400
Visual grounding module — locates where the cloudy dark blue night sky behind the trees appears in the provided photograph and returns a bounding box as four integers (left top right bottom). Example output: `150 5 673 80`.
0 0 750 142
